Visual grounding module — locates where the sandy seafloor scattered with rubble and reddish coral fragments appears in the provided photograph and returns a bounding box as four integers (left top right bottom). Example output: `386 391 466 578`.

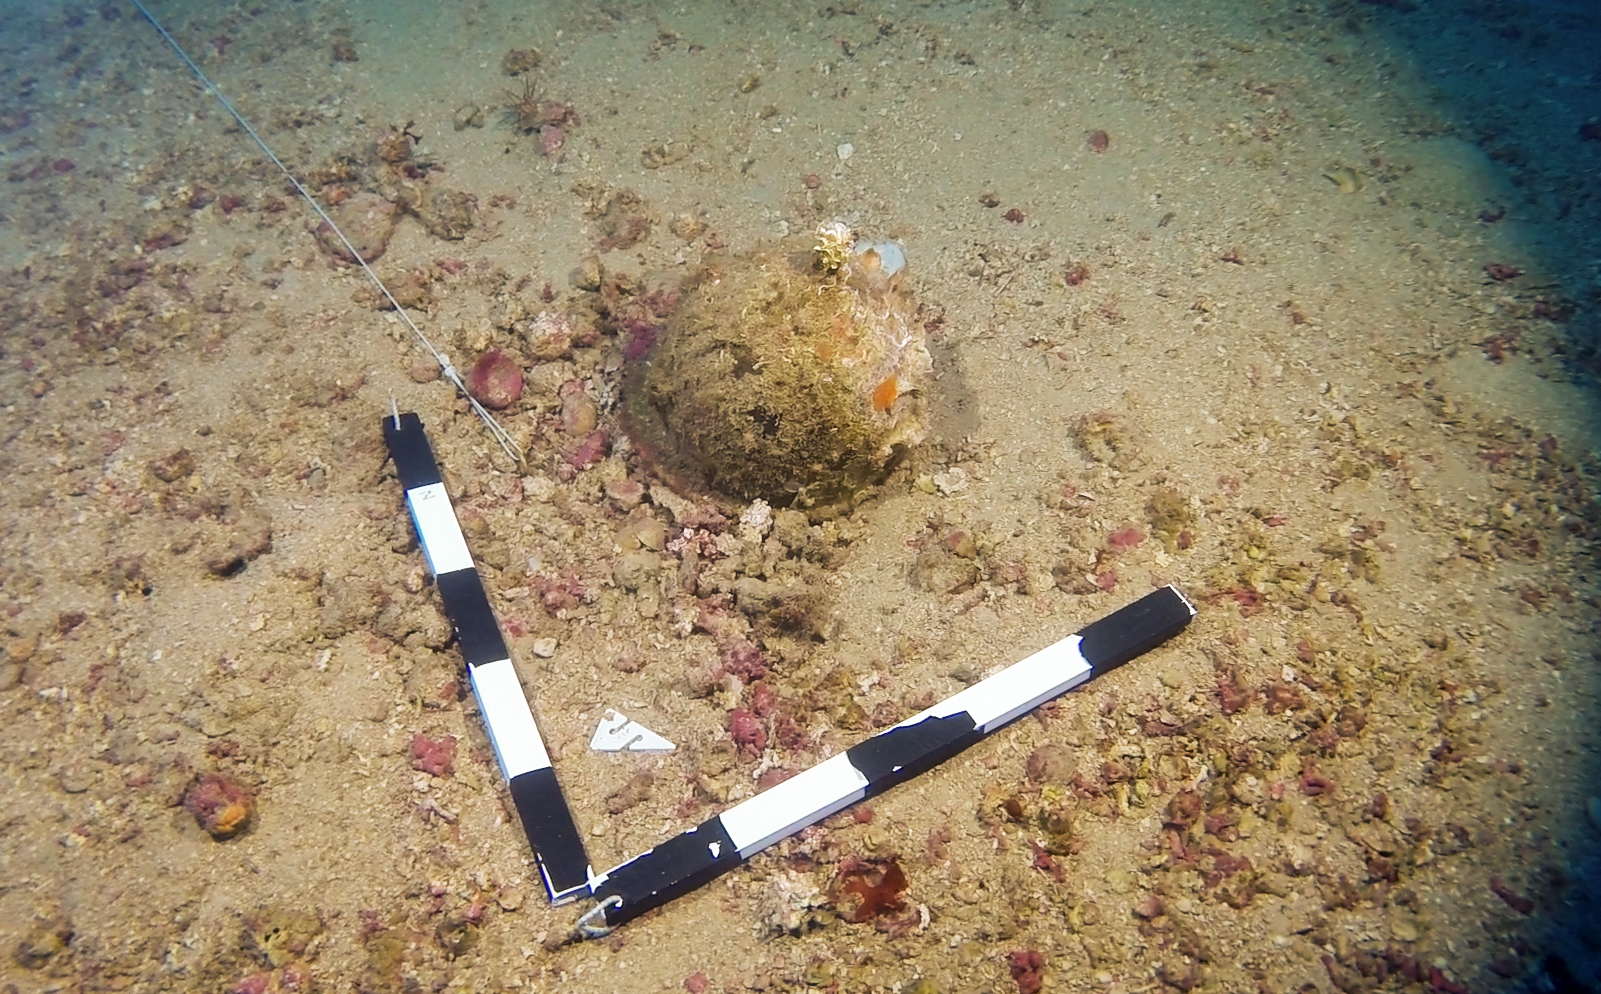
0 0 1601 994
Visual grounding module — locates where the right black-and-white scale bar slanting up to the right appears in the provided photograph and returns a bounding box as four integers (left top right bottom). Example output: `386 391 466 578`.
586 586 1196 927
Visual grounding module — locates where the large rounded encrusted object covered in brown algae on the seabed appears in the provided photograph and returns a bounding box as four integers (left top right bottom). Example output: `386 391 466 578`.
626 222 932 517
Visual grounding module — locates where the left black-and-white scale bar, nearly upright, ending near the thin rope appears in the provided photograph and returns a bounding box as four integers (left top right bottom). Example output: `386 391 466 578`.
384 413 591 904
